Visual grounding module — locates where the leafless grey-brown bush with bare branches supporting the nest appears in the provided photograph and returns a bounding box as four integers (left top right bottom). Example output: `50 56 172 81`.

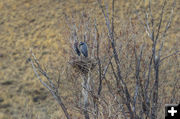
29 0 180 119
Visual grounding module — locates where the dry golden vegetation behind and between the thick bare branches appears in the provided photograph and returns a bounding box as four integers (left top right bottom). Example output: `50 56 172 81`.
0 0 180 119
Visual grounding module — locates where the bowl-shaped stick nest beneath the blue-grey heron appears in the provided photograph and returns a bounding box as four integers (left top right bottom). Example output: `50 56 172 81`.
69 57 97 74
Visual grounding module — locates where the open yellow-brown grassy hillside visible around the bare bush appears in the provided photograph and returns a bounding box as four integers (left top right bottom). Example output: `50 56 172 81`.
0 0 180 119
